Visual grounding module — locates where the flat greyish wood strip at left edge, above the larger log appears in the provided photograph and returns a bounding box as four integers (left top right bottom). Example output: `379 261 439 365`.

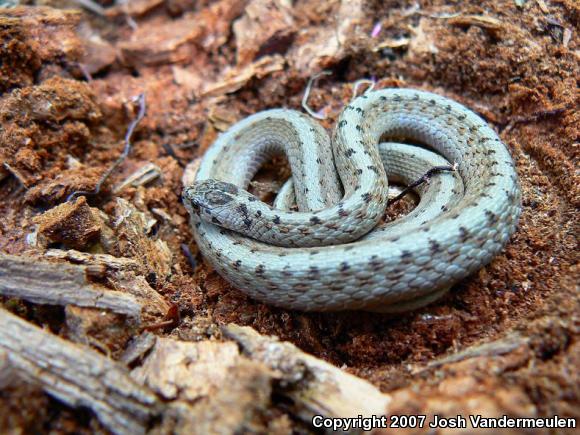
0 254 141 319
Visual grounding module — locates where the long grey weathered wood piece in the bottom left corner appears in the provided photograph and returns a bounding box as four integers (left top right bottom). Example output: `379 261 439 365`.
0 309 160 434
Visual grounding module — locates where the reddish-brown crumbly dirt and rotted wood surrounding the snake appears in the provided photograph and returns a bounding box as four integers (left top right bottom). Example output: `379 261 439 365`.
0 0 580 433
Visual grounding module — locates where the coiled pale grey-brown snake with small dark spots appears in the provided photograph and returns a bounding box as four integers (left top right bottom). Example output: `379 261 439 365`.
182 88 521 313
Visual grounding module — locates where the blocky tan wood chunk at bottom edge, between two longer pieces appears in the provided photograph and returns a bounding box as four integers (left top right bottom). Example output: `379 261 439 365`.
132 338 290 435
